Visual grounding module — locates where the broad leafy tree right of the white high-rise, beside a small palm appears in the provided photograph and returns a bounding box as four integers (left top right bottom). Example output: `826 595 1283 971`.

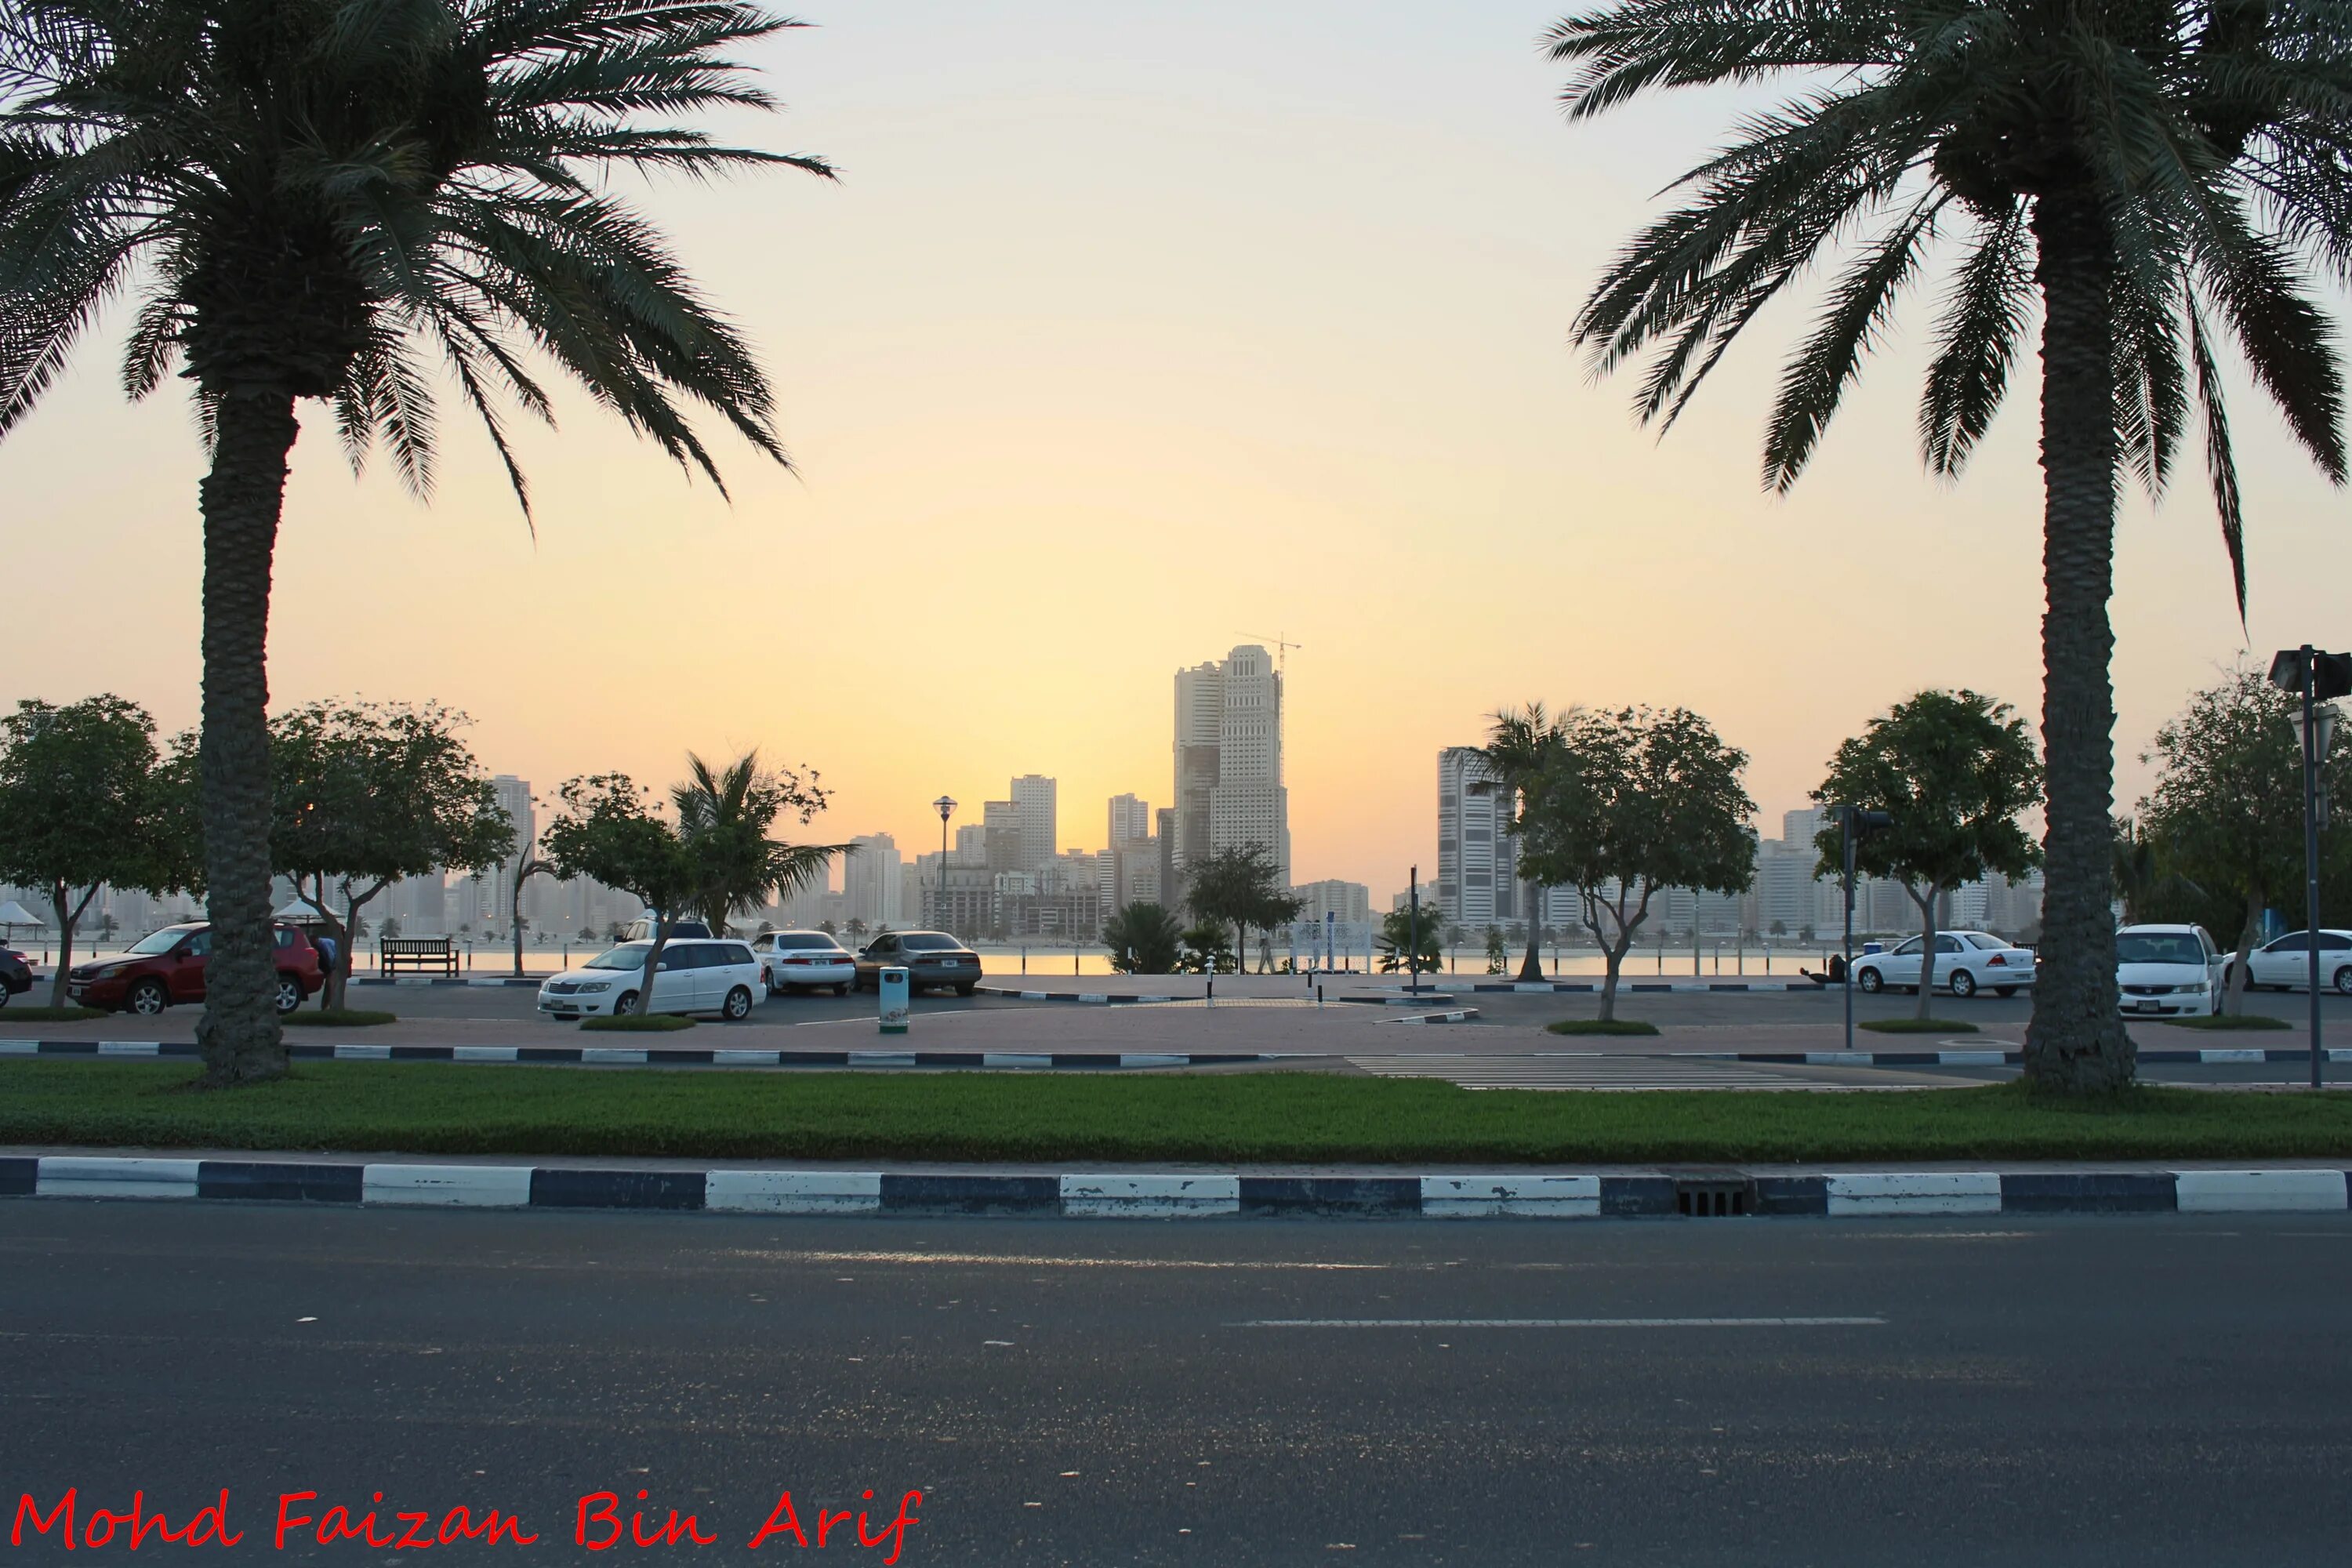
1519 708 1757 1018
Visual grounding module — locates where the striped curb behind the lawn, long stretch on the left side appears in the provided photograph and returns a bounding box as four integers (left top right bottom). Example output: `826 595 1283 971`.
0 1044 1289 1067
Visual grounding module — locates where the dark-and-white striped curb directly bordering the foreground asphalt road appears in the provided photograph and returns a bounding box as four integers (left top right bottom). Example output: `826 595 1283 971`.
0 1154 2347 1220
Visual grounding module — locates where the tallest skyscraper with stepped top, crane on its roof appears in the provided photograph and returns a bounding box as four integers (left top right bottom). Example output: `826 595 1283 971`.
1176 644 1291 886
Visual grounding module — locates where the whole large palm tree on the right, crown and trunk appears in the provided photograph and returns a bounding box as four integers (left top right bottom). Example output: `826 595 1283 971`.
1548 0 2352 1093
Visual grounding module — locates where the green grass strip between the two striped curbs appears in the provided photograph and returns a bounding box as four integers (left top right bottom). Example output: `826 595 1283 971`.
0 1060 2352 1163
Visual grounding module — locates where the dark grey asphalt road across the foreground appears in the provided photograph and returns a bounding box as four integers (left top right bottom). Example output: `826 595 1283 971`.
0 1199 2352 1568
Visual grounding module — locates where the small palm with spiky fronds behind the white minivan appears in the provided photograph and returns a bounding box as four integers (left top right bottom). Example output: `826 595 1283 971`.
670 753 842 935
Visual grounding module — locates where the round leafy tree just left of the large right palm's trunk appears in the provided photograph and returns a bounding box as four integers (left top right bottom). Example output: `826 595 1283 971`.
1813 691 2042 1018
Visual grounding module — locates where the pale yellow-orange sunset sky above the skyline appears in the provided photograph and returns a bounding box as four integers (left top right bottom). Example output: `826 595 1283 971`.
0 0 2352 907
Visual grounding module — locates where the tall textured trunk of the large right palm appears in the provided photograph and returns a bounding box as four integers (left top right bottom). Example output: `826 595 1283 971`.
2025 191 2138 1093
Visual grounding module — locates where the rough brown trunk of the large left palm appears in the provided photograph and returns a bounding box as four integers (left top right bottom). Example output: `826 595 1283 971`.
195 390 299 1086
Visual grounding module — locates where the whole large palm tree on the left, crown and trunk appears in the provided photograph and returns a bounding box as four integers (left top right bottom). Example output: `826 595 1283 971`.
0 0 828 1083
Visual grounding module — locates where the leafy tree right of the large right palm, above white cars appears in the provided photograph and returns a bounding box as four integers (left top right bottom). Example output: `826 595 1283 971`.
2136 668 2352 1013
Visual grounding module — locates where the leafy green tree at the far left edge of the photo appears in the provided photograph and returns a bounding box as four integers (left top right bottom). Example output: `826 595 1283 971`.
0 694 172 1006
